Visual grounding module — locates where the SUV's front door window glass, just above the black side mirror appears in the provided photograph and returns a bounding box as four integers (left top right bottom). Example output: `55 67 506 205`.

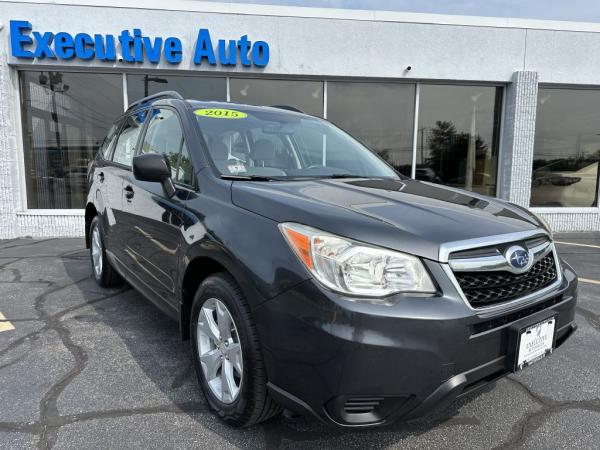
142 109 192 184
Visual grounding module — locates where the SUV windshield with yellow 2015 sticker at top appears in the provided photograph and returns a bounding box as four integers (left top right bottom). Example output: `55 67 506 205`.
194 105 399 179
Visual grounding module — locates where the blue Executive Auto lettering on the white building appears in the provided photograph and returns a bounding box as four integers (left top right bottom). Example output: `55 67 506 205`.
10 20 269 67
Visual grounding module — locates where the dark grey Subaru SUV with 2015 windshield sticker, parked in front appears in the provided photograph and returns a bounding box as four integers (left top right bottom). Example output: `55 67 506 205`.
85 92 577 426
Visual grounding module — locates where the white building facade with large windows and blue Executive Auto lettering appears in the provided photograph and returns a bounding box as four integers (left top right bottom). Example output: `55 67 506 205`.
0 0 600 238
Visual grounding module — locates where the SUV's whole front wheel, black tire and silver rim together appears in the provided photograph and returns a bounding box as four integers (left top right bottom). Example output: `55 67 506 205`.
190 273 281 427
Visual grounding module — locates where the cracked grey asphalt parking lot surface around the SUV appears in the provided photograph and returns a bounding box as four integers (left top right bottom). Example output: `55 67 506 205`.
0 233 600 449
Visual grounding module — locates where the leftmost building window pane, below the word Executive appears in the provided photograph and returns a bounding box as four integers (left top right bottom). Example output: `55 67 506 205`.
20 71 123 209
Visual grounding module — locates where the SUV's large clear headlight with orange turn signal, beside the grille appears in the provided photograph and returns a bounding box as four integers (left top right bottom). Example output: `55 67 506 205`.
279 223 436 297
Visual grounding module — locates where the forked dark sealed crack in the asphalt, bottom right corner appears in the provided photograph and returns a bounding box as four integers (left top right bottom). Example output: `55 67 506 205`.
494 377 600 450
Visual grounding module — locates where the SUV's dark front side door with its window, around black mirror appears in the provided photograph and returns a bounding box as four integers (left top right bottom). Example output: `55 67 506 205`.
118 107 194 308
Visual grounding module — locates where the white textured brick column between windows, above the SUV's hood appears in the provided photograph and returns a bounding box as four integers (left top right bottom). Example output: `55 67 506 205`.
498 71 538 208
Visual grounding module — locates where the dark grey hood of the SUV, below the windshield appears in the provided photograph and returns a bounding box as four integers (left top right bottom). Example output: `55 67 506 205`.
232 179 544 260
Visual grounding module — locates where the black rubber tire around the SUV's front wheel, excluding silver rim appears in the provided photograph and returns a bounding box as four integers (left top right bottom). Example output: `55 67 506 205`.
190 275 256 424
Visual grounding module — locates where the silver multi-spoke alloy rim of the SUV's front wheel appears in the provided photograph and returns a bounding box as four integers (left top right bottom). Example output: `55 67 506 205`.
196 298 244 404
